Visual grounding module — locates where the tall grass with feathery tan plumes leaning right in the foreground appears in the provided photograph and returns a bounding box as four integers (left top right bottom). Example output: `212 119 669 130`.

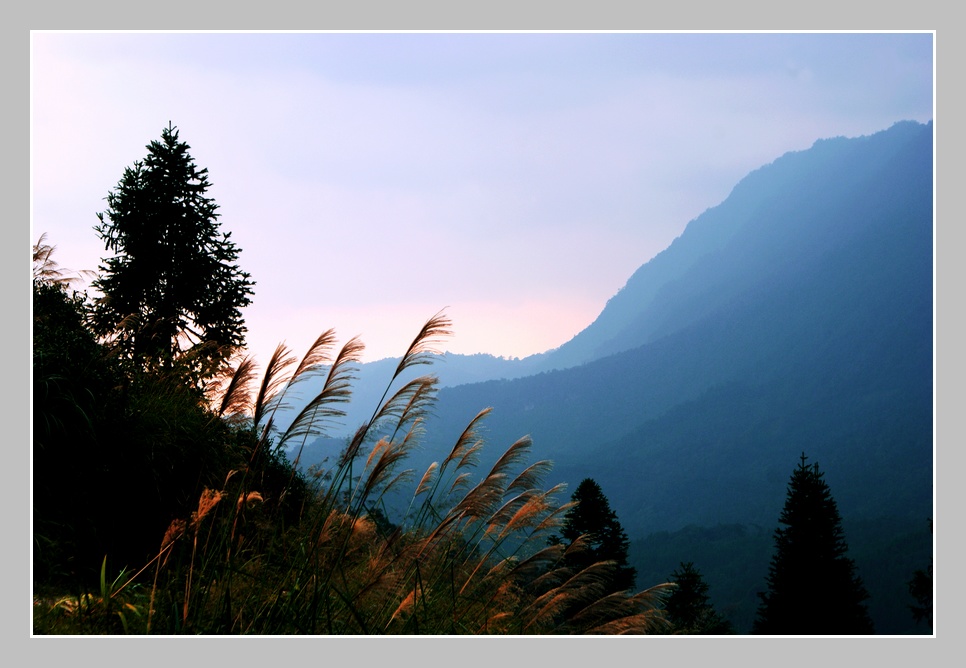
41 314 669 635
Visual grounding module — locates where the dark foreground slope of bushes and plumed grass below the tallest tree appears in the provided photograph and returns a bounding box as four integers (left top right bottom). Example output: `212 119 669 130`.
33 213 667 635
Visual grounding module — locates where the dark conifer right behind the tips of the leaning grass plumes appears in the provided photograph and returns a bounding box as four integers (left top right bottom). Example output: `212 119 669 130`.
560 478 637 592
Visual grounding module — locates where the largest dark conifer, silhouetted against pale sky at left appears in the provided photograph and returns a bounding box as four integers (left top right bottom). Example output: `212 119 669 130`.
92 124 254 378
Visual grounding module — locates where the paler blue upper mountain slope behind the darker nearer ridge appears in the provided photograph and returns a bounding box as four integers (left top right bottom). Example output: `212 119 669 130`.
541 122 932 368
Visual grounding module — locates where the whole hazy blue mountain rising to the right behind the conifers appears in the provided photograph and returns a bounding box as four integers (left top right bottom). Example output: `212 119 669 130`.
286 122 934 632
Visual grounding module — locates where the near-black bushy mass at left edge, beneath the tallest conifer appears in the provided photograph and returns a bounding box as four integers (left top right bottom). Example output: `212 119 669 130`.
32 243 298 586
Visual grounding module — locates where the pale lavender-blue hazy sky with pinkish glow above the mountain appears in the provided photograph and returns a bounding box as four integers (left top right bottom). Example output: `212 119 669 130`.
31 32 934 362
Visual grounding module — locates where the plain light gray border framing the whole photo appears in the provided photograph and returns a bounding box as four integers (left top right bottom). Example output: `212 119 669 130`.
15 0 963 665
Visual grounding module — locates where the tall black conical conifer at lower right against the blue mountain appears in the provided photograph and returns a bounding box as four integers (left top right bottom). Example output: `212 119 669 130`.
752 453 874 635
